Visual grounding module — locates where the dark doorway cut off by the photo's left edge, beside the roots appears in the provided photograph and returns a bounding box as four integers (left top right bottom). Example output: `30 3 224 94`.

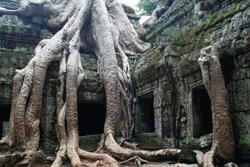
0 104 10 139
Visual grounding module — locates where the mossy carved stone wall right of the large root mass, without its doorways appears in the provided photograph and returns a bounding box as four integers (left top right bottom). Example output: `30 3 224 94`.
133 0 250 160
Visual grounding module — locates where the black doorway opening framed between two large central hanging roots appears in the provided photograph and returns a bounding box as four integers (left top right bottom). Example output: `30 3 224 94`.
78 103 106 136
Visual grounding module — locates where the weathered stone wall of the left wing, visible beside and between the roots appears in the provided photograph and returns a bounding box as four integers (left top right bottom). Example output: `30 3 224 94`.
0 6 104 154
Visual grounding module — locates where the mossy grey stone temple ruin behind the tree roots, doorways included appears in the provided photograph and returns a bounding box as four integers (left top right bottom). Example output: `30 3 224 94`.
0 0 250 166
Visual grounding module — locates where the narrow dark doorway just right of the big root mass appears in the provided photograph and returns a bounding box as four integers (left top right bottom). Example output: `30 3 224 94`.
136 96 155 133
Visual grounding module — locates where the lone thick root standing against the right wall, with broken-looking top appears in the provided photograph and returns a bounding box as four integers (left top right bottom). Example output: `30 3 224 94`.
198 43 235 167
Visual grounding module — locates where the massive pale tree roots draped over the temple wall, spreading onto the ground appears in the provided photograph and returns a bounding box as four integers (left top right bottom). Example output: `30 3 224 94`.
0 0 180 167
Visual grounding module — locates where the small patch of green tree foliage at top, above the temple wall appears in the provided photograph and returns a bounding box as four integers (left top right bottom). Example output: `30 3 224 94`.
138 0 165 15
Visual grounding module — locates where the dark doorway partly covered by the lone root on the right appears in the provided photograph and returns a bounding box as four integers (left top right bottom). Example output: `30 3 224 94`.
192 86 213 137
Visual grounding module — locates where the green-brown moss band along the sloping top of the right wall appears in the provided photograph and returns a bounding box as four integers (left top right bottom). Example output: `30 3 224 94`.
173 3 246 74
